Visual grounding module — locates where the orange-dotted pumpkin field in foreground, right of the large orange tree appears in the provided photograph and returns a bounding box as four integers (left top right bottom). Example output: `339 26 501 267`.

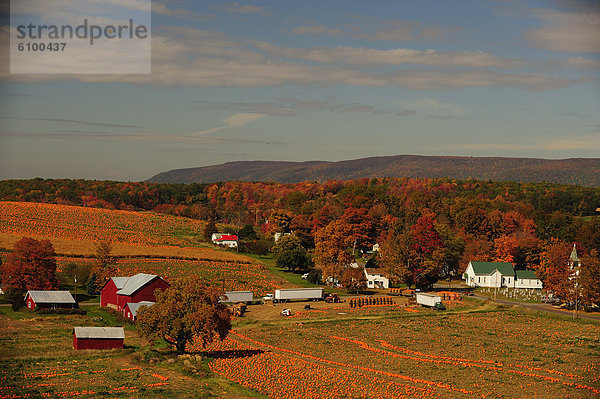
204 310 600 398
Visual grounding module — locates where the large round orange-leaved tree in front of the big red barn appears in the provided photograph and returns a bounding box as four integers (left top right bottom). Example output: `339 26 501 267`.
136 276 231 354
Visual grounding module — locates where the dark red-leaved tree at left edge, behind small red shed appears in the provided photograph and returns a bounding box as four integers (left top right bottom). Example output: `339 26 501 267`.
0 237 59 292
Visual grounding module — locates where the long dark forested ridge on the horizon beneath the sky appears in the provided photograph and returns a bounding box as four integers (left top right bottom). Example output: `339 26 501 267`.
148 155 600 187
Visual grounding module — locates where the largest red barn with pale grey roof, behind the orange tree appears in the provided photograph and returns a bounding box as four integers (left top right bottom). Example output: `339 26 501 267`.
100 273 171 311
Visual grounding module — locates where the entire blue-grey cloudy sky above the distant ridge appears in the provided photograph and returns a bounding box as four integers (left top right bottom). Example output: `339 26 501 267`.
0 0 600 181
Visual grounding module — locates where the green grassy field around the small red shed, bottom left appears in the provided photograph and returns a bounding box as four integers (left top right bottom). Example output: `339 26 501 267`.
0 307 263 398
